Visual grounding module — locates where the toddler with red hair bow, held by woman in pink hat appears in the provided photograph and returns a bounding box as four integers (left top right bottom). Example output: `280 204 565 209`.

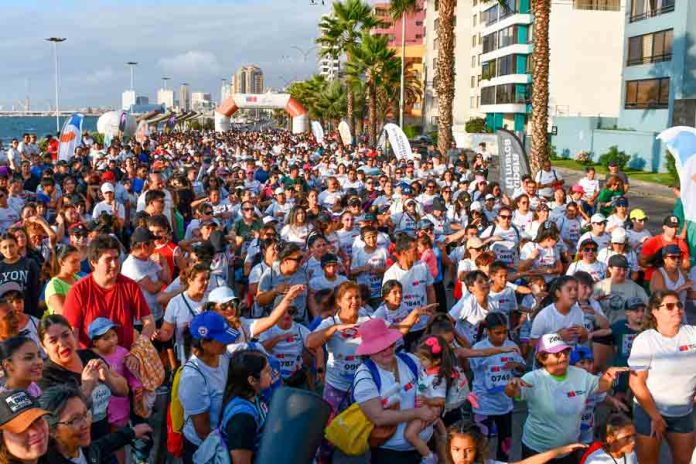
404 335 454 464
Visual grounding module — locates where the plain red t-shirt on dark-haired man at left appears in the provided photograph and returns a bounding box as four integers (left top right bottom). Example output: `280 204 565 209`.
63 274 150 350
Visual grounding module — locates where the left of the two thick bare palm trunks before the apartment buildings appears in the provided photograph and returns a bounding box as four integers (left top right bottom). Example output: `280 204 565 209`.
435 0 457 153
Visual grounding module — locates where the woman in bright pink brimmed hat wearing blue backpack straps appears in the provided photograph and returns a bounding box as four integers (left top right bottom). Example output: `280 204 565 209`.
353 319 438 464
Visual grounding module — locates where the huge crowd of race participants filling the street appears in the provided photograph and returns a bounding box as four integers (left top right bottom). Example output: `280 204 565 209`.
0 130 696 464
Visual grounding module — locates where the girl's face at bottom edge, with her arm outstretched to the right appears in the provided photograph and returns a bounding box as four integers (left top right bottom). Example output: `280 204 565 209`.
445 422 585 464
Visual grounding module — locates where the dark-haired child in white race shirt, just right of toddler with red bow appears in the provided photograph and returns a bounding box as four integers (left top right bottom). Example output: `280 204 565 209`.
469 312 524 461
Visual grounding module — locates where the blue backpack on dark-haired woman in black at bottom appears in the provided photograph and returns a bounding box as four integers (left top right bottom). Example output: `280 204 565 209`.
193 396 265 464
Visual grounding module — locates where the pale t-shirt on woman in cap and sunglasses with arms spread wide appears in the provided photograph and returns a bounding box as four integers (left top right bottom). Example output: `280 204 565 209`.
520 366 599 452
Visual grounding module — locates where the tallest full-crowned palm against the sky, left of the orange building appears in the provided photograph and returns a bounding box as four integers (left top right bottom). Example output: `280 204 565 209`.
317 0 382 132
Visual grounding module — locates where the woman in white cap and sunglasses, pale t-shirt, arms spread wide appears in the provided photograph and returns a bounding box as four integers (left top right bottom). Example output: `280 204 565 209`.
505 333 628 464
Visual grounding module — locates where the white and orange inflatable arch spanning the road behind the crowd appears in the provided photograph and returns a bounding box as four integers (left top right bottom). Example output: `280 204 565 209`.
215 93 309 134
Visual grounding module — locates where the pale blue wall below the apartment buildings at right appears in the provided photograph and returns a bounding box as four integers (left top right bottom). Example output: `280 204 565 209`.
551 117 665 172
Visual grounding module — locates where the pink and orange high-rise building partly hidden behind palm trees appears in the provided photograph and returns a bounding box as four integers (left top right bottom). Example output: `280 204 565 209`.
372 0 426 125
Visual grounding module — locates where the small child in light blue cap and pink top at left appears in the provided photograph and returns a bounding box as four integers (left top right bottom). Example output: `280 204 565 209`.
87 317 142 463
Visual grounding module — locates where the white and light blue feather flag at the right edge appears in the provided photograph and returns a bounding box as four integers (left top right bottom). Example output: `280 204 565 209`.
657 126 696 221
